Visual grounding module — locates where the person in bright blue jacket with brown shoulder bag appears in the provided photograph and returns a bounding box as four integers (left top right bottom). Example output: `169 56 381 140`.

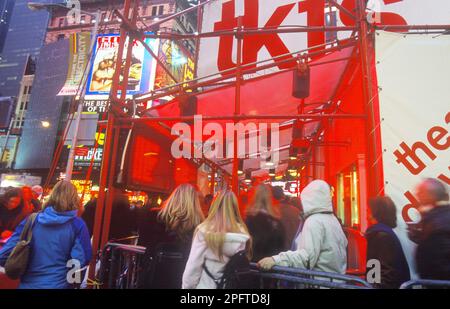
0 181 92 289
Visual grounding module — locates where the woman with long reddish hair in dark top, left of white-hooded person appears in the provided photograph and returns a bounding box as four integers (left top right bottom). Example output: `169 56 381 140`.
245 184 285 261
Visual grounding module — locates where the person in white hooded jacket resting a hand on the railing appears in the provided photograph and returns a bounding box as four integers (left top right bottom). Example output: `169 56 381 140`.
258 180 347 274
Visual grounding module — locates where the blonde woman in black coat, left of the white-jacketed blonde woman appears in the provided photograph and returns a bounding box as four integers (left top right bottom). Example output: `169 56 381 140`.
138 184 204 289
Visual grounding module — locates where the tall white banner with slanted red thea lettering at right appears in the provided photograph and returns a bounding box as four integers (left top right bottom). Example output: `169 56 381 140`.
376 32 450 276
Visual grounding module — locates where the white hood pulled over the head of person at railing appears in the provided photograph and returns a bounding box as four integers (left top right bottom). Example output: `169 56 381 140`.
300 180 333 216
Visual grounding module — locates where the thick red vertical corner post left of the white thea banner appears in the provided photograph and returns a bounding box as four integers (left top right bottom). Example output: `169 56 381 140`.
357 0 380 198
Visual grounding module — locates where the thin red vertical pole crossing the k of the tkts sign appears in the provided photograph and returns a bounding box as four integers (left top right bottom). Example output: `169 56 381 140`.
232 17 242 196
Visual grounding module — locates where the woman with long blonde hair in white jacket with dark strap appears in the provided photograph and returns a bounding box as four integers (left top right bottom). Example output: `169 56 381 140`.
183 191 251 289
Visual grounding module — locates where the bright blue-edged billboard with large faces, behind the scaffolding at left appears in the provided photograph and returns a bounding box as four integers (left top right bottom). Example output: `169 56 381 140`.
86 34 158 99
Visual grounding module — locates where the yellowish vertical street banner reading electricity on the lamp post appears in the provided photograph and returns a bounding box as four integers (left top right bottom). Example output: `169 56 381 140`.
58 32 91 96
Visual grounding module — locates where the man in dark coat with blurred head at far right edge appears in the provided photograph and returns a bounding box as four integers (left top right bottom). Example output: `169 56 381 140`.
409 178 450 280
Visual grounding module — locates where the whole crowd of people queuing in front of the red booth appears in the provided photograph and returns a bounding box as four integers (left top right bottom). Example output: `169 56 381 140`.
0 179 450 289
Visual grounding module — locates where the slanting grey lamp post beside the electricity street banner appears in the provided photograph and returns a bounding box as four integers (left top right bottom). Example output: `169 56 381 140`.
65 10 100 181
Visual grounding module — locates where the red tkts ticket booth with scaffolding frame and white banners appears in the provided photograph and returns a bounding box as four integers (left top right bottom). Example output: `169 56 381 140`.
85 0 450 280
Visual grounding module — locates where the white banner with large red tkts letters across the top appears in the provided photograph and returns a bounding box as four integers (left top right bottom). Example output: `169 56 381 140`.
198 0 450 77
